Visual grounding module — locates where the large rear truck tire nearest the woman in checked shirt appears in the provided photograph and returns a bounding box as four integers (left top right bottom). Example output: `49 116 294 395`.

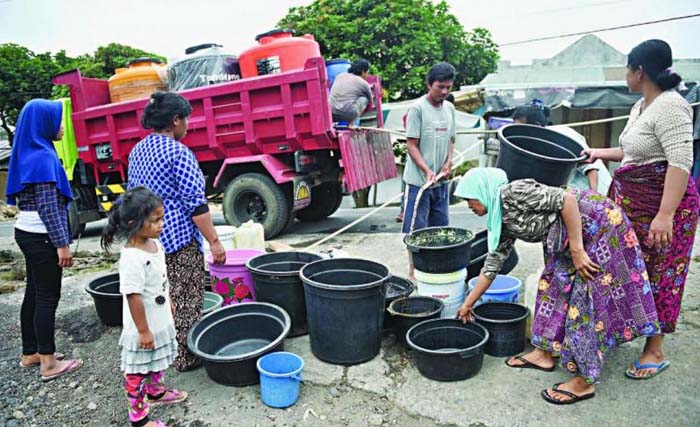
223 173 291 239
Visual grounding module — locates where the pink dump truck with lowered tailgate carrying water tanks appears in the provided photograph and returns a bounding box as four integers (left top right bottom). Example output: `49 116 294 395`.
53 58 396 238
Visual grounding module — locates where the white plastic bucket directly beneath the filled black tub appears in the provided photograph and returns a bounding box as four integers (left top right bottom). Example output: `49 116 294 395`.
416 268 467 310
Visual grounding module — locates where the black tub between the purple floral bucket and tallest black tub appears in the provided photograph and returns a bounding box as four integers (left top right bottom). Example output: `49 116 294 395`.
246 252 321 337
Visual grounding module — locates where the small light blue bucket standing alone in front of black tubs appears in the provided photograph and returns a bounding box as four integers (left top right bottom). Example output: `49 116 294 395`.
257 351 304 408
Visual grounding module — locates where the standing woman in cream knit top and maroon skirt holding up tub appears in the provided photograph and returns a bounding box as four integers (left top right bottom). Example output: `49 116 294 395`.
587 40 700 379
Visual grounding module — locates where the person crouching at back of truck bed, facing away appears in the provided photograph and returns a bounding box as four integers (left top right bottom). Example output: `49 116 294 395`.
330 58 372 124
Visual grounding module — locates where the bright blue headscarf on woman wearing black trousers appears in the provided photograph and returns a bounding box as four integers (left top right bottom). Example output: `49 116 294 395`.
6 99 73 205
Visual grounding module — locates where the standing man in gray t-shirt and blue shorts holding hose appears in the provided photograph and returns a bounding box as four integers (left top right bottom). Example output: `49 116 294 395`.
403 62 456 279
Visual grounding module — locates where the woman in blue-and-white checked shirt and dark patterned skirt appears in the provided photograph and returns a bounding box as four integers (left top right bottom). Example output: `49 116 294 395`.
128 92 226 372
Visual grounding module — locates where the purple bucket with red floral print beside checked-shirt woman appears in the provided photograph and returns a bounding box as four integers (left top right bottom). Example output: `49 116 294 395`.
207 249 264 306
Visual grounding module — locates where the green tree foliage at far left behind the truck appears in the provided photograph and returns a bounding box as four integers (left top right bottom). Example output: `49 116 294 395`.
0 43 164 143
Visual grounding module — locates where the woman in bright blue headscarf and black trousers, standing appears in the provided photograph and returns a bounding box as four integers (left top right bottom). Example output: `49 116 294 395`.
6 99 83 381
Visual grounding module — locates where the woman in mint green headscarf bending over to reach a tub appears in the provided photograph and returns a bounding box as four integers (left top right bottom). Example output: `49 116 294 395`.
455 168 659 405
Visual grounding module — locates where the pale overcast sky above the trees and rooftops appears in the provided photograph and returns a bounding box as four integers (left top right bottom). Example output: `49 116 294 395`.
0 0 700 64
